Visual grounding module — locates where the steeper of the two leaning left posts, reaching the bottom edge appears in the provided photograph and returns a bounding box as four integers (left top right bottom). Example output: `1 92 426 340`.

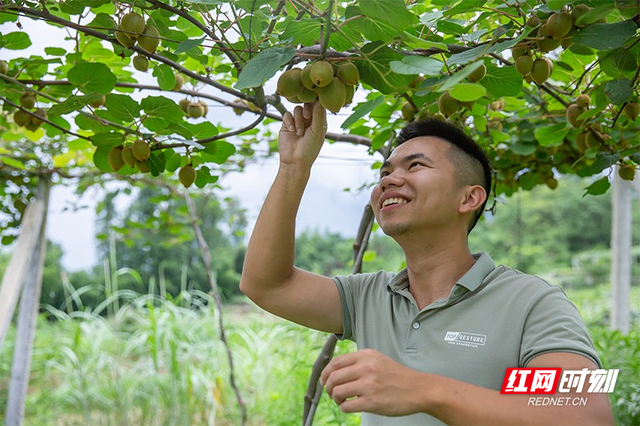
6 176 51 426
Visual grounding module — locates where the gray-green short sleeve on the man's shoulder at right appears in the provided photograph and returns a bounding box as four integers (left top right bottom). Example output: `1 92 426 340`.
520 285 602 368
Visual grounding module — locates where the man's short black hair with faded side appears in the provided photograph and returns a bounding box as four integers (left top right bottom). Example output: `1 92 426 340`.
396 118 492 232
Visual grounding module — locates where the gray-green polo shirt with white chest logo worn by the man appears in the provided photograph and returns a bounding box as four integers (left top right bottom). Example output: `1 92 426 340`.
334 253 601 426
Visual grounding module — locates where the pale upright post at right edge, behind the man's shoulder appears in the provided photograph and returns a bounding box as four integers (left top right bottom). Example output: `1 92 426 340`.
611 166 633 334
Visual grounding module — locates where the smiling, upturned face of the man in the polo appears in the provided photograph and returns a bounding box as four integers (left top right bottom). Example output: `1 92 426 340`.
371 136 464 237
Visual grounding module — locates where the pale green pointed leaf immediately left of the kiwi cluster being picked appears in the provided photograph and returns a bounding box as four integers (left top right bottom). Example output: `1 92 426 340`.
234 47 296 90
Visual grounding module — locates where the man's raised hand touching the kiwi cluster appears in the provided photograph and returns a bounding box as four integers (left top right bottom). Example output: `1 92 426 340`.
278 102 327 168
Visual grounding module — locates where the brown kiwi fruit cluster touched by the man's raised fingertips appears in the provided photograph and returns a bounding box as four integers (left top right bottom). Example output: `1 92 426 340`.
277 60 360 113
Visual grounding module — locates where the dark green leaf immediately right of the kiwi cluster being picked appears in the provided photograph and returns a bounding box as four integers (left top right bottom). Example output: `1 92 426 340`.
356 42 413 94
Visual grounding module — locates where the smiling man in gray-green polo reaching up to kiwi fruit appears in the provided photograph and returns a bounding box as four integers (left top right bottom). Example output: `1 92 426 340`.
240 103 613 426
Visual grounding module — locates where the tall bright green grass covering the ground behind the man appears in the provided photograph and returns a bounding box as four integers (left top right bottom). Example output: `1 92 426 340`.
0 288 640 426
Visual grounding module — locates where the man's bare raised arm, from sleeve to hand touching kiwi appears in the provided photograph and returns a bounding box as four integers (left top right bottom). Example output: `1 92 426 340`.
240 102 342 333
